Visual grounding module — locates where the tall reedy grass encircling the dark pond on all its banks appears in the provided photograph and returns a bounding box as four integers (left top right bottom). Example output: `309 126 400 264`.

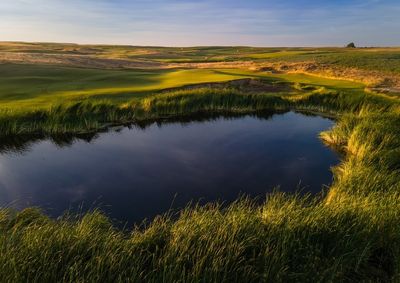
0 59 400 282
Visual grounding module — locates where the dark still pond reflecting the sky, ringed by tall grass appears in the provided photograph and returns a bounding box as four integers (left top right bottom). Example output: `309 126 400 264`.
0 112 338 223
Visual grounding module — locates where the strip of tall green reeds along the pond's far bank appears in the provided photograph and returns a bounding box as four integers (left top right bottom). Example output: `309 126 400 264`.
0 84 387 136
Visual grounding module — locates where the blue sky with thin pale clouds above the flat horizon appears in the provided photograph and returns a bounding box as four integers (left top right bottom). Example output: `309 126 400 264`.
0 0 400 46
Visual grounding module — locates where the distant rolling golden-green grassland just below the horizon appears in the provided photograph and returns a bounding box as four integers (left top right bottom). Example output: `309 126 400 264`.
0 42 400 74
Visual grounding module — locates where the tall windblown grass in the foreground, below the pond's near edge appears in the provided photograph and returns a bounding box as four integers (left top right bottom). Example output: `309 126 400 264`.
0 194 400 282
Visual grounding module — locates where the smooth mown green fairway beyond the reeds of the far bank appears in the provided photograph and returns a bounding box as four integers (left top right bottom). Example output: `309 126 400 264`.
0 64 364 110
